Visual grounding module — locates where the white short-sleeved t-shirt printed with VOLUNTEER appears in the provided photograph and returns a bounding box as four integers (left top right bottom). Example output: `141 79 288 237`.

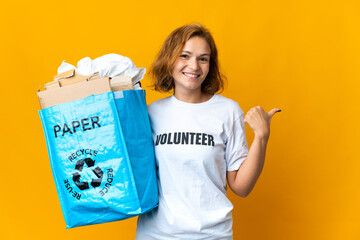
136 94 248 240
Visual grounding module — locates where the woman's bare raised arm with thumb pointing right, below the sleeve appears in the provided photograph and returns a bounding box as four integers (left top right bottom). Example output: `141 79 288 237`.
227 106 281 197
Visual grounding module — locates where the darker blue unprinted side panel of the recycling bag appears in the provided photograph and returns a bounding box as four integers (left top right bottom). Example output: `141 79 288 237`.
114 90 158 212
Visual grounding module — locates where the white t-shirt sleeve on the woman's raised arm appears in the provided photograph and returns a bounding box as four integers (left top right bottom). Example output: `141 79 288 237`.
225 113 249 171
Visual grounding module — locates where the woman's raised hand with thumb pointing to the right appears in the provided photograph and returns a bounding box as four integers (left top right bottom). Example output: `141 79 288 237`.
244 106 281 139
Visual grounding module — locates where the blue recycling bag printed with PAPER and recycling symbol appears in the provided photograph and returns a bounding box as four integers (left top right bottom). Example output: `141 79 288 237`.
39 90 158 228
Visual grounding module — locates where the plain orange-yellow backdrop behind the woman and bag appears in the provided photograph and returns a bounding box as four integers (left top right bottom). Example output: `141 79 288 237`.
0 0 360 240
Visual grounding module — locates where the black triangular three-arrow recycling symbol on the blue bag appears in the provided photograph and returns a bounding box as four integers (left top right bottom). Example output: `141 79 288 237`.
73 158 104 190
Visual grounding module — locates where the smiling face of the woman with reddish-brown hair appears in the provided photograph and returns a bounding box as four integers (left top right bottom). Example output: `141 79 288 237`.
172 37 210 92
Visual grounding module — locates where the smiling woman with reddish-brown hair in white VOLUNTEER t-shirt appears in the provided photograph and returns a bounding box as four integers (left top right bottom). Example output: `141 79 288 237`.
136 24 280 240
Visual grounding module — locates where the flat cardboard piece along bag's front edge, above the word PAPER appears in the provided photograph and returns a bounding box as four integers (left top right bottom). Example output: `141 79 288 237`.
38 77 111 109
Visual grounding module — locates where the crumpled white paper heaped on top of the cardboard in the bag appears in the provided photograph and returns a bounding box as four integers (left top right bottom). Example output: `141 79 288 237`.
58 53 146 85
